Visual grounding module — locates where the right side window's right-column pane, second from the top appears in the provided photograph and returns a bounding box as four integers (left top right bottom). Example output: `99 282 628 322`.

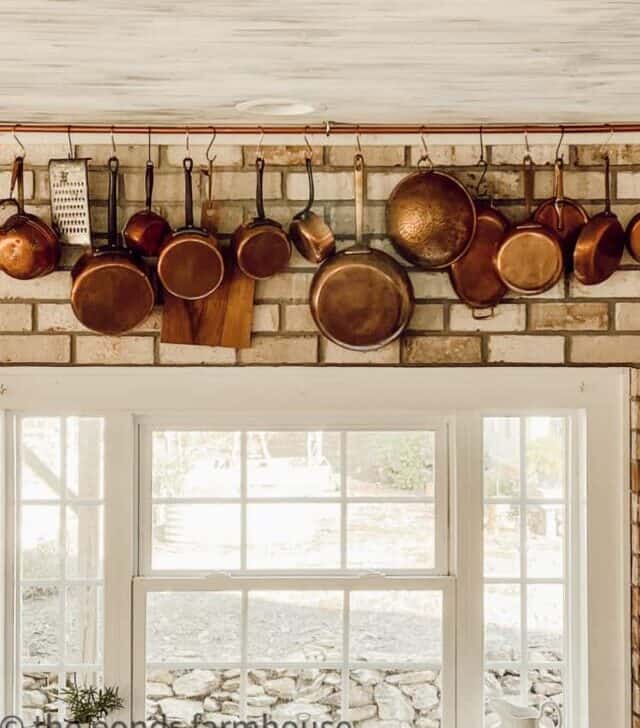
527 506 565 579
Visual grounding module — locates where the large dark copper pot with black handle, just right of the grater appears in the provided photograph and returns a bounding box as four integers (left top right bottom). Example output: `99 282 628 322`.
71 157 154 335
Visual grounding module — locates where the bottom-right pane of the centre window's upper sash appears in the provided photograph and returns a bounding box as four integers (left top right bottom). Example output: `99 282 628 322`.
347 503 435 569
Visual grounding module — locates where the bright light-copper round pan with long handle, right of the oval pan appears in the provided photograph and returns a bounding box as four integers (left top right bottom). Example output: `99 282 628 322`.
495 154 563 296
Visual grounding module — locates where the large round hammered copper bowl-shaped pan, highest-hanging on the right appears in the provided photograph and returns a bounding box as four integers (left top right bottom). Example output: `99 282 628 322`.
387 160 476 269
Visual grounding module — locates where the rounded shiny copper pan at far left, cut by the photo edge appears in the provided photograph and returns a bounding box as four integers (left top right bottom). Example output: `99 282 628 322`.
0 157 61 280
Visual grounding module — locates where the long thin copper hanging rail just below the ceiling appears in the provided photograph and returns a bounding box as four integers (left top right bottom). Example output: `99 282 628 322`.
0 121 640 136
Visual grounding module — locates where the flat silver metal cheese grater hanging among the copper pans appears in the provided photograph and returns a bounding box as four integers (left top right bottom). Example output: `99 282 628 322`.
49 159 91 245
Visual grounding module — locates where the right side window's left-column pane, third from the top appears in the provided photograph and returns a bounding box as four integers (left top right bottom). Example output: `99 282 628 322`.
484 584 521 662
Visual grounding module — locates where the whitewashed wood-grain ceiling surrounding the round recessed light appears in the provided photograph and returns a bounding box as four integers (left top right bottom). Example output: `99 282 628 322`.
0 0 640 123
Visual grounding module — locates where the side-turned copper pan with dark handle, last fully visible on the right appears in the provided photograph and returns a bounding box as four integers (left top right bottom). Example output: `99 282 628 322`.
573 155 625 286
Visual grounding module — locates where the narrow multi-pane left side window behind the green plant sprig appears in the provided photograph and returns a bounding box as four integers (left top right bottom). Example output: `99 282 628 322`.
15 416 104 721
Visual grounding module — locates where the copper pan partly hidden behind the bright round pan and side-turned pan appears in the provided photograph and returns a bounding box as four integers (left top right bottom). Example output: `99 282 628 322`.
533 157 589 270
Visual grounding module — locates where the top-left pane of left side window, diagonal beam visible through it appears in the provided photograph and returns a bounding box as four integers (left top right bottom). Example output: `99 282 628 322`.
20 417 62 500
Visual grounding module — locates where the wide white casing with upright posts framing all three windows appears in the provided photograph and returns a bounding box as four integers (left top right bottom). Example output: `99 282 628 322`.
0 367 631 728
